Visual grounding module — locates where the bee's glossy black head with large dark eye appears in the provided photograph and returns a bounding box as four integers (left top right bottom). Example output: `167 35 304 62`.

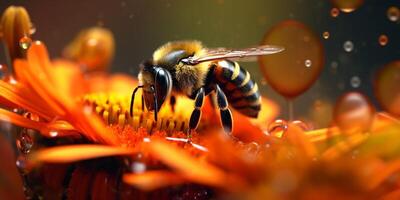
139 62 172 112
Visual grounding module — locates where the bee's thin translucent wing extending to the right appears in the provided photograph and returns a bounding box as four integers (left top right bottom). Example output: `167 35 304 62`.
182 45 284 65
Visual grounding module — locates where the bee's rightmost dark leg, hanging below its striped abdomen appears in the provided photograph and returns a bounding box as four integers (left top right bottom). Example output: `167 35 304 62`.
215 85 232 134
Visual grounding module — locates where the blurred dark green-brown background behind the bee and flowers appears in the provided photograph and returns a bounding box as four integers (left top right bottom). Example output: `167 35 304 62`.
0 0 400 126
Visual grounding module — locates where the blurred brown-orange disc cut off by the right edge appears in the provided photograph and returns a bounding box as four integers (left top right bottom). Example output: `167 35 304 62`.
374 60 400 116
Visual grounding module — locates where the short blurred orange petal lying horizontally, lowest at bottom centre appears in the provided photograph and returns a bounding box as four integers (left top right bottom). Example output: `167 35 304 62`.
123 171 185 191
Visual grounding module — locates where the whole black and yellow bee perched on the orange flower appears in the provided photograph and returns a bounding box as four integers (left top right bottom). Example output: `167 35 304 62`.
130 41 284 134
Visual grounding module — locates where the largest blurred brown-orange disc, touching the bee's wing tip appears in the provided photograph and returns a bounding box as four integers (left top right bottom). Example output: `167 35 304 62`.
260 20 324 98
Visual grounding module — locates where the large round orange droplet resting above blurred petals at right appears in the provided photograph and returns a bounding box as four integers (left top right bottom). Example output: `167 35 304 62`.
334 92 375 134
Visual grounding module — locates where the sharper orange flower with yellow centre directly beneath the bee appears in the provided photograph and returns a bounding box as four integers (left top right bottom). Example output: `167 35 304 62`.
0 37 282 195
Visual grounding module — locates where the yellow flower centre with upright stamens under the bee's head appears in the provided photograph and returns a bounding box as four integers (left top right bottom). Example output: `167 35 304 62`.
83 92 194 132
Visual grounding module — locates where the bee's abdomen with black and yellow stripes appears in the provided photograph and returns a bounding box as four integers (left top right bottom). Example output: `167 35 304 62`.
214 60 261 117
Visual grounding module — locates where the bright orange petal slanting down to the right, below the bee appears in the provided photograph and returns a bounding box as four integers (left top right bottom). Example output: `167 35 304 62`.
145 140 242 187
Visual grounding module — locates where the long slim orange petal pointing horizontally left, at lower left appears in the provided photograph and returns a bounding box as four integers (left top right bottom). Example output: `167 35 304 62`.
30 144 136 163
